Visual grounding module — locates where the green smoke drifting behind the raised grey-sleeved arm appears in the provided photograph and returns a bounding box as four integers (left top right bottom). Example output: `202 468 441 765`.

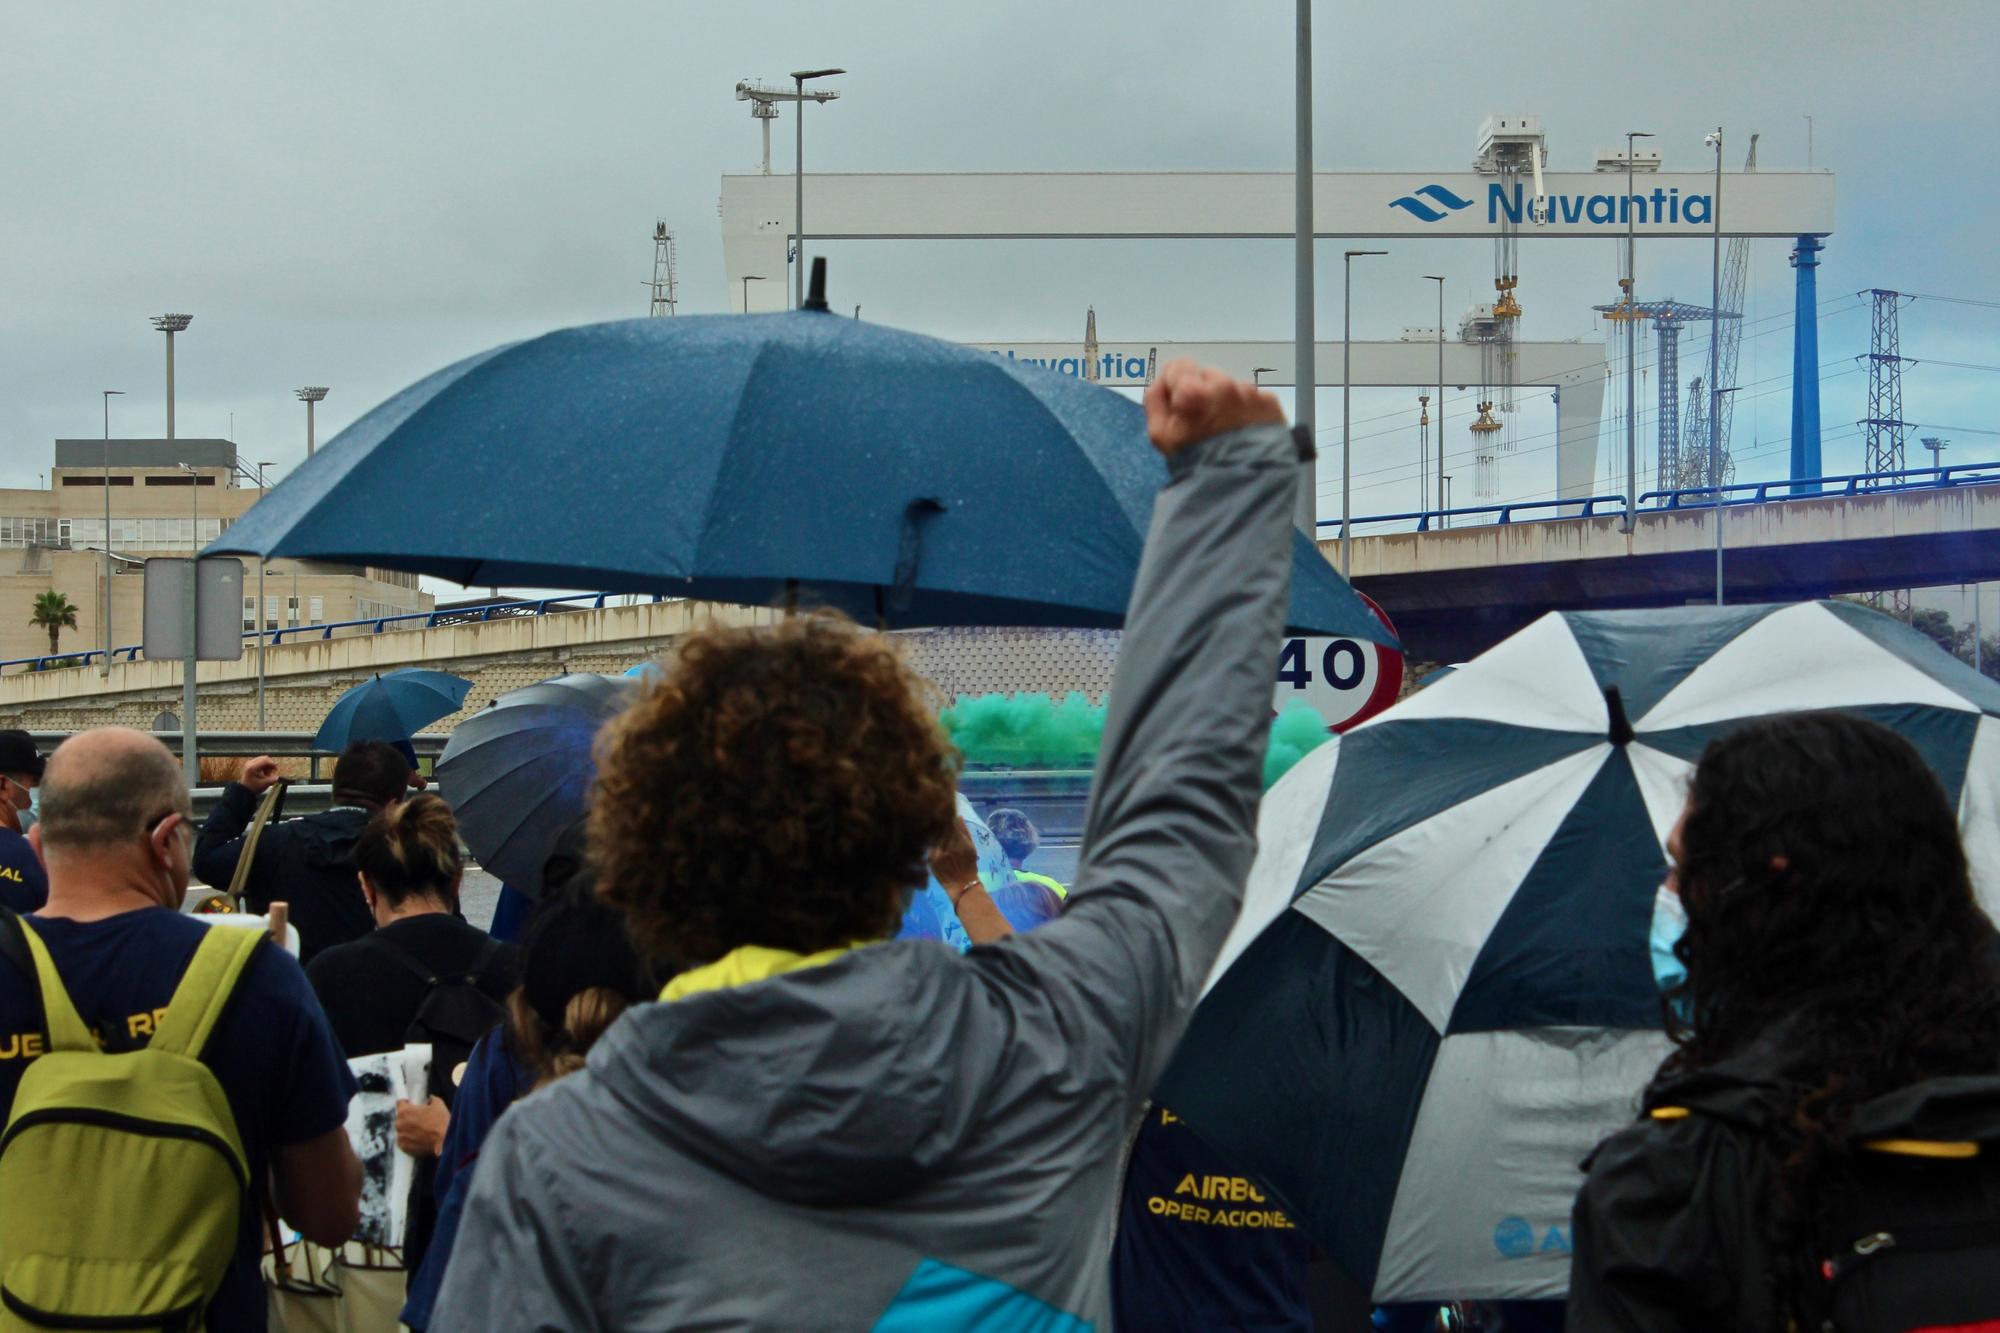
940 695 1326 787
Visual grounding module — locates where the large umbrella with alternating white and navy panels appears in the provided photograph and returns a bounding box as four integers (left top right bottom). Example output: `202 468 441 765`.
1158 602 2000 1301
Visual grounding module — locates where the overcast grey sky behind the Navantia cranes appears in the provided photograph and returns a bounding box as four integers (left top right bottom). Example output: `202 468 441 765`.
0 0 2000 528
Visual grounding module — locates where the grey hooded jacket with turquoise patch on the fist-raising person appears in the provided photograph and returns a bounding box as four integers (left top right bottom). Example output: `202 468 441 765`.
432 426 1298 1333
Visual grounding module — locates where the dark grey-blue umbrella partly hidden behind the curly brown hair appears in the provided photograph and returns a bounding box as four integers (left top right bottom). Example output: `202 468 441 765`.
438 673 638 899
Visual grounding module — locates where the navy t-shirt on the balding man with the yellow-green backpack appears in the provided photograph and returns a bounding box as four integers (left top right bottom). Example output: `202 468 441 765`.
0 907 354 1329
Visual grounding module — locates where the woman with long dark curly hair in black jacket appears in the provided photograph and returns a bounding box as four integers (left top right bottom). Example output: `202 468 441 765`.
1570 713 2000 1333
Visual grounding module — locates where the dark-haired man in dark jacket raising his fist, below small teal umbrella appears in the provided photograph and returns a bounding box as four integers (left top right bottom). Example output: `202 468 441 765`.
194 741 410 963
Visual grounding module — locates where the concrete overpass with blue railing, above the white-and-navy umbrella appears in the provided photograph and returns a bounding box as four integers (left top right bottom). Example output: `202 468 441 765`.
1320 480 2000 662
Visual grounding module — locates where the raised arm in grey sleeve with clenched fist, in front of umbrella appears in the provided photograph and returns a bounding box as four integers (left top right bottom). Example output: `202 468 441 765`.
990 362 1300 1095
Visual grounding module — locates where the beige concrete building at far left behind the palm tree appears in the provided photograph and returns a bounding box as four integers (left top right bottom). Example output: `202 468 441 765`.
0 438 434 662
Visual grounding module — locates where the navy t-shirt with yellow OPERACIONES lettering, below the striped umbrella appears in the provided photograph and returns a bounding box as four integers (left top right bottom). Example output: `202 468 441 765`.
1112 1107 1312 1333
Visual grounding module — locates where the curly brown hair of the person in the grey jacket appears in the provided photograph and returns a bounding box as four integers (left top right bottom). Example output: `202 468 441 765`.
590 612 958 963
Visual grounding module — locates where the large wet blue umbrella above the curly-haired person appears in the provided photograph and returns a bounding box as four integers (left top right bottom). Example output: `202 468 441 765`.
212 264 1390 642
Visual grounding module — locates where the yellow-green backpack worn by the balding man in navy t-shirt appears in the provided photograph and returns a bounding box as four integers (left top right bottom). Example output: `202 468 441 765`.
0 913 264 1333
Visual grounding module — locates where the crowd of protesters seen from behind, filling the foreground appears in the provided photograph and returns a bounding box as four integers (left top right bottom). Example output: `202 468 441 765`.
0 364 2000 1333
